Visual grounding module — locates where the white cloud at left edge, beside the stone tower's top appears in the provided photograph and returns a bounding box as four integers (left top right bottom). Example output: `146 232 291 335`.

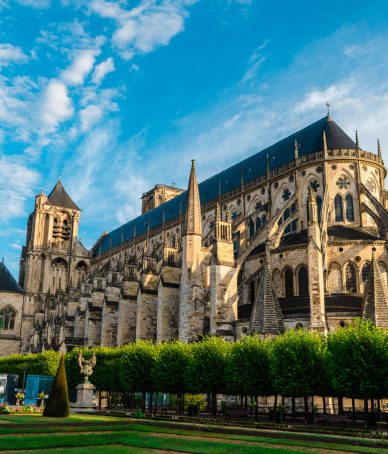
0 155 39 222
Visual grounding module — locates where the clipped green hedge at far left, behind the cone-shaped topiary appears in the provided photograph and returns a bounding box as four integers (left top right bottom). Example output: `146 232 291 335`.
0 350 59 386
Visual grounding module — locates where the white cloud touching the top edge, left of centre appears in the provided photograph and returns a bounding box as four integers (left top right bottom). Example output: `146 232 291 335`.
88 0 196 60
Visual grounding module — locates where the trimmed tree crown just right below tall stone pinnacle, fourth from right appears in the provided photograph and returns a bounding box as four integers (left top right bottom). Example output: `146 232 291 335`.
185 337 230 393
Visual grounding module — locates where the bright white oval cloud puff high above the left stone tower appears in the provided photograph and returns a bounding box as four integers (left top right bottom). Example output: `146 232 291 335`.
40 79 73 131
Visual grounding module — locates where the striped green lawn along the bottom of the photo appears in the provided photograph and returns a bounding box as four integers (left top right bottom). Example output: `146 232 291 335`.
0 415 388 454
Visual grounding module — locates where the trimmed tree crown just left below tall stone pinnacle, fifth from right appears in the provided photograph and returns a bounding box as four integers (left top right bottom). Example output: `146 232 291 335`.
152 341 190 394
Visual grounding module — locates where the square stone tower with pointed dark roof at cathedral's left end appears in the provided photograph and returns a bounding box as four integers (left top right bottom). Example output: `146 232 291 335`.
19 179 89 351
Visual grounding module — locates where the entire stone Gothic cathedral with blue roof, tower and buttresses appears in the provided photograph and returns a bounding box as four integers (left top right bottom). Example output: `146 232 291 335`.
0 114 388 354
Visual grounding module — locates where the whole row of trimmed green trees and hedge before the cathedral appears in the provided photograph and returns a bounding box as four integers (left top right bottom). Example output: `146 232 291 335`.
0 321 388 424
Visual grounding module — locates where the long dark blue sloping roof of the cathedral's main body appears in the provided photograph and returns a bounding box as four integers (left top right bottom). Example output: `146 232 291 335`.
94 117 356 255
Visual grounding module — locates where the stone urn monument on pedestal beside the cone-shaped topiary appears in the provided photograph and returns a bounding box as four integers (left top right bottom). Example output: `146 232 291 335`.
71 352 96 413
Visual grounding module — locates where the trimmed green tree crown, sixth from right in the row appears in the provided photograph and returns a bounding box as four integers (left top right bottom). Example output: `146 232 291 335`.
118 340 158 393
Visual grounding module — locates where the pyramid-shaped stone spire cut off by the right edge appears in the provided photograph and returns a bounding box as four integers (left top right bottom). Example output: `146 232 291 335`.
362 248 388 328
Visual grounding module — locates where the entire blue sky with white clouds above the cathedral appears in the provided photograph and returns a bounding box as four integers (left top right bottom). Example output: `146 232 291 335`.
0 0 388 275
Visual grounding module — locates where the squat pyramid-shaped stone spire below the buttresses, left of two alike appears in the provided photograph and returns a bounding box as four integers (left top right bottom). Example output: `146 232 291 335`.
249 263 284 335
